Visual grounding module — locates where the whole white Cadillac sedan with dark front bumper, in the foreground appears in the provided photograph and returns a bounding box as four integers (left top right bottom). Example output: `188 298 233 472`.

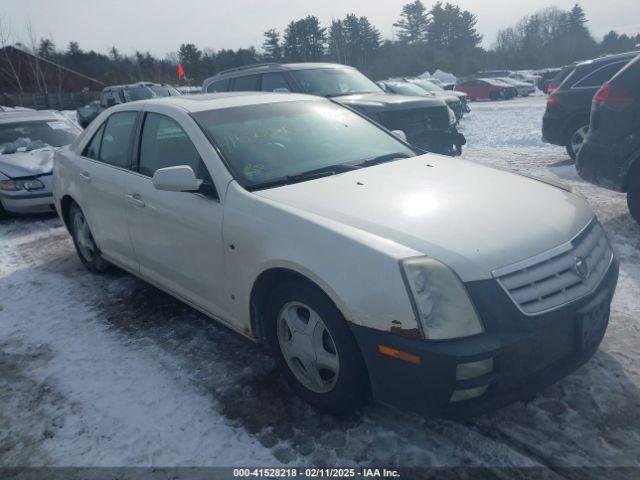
54 93 618 416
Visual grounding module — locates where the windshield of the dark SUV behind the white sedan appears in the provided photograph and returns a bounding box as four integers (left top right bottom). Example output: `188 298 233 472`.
291 68 382 97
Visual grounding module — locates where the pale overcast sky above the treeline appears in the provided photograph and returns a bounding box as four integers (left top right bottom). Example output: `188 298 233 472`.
0 0 640 56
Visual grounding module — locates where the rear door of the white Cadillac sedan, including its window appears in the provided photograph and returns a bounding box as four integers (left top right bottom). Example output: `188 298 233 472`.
79 111 138 270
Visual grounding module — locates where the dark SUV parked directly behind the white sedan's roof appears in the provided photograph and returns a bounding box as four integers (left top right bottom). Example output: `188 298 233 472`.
202 63 466 155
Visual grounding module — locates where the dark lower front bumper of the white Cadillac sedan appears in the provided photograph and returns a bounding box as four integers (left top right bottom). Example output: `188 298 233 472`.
352 257 618 417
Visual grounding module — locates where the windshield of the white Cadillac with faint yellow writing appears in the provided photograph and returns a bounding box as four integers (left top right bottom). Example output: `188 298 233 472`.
192 100 416 190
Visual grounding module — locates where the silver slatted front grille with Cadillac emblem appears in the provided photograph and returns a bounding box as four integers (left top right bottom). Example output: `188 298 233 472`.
493 219 613 315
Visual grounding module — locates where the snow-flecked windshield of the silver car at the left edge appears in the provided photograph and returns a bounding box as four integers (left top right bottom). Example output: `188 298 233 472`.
0 119 80 153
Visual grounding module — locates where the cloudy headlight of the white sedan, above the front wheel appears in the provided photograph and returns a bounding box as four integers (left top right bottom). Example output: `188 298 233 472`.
400 257 484 340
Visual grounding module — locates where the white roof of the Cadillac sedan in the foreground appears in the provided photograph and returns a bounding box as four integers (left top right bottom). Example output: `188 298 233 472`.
110 92 328 113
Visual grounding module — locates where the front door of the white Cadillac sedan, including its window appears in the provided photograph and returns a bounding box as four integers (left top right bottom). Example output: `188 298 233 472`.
126 111 228 318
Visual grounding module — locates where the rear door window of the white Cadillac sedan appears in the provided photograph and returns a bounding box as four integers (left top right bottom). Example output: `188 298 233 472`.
100 112 138 168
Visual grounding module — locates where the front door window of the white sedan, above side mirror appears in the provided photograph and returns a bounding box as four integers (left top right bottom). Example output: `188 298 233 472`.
139 113 209 179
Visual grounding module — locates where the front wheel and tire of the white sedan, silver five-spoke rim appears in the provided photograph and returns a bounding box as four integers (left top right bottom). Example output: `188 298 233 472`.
266 281 368 414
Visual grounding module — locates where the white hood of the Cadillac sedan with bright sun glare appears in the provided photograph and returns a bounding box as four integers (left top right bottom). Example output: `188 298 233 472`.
256 154 593 281
